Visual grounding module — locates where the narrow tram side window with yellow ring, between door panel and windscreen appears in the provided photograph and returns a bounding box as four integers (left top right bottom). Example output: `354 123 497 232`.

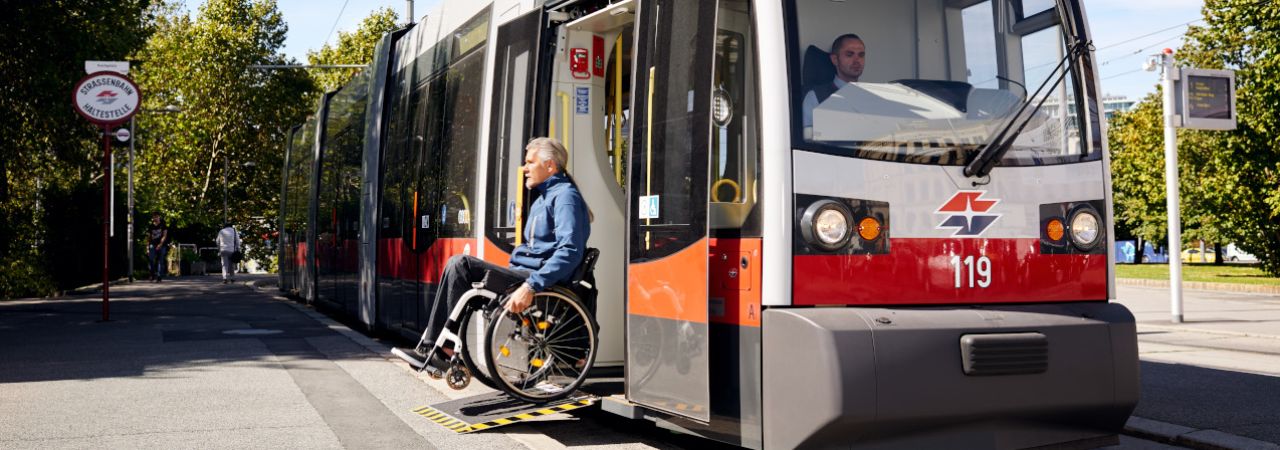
709 0 759 234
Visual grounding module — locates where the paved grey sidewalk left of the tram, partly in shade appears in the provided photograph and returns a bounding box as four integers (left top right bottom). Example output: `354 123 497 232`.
0 276 526 449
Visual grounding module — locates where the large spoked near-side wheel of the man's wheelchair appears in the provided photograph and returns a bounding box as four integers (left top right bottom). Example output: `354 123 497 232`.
485 288 599 403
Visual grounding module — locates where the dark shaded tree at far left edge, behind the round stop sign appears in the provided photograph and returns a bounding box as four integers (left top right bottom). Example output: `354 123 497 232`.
0 0 160 298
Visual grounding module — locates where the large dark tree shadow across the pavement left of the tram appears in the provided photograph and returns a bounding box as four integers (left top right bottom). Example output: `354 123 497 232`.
0 276 357 384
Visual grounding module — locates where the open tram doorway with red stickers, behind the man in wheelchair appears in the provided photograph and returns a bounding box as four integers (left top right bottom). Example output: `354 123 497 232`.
483 1 634 369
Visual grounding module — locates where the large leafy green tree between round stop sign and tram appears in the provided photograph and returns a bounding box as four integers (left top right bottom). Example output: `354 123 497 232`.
136 0 314 263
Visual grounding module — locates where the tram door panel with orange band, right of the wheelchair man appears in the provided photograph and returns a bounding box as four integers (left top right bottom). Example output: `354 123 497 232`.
626 0 717 422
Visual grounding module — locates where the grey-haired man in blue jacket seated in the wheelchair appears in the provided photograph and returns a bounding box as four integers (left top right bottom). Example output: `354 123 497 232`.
420 137 591 350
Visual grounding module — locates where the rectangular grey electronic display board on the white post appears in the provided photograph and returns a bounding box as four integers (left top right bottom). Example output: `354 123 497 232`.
1174 69 1235 129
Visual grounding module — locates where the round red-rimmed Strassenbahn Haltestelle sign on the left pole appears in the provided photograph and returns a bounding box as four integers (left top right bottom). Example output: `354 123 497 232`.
72 72 142 127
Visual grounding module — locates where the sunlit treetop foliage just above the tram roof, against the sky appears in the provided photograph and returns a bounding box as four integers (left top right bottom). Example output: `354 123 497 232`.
307 8 398 92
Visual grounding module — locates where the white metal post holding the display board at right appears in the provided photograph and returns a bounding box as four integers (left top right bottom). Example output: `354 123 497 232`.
1161 49 1183 323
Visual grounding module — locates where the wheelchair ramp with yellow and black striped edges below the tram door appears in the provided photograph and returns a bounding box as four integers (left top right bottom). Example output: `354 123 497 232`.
413 392 600 433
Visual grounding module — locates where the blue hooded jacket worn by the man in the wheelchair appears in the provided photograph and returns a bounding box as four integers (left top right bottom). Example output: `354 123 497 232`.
511 174 591 291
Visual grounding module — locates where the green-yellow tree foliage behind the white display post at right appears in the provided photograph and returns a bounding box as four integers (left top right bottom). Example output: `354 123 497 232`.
1110 0 1280 274
